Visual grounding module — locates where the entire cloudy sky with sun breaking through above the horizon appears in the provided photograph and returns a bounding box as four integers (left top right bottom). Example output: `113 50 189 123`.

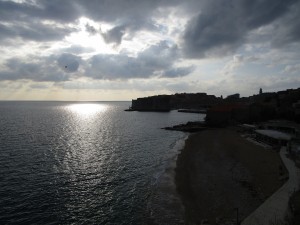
0 0 300 101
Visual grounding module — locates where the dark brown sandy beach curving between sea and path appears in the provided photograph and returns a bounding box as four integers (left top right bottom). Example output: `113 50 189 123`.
175 128 286 224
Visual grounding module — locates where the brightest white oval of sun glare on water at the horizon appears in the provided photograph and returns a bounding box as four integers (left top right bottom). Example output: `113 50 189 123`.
68 103 107 117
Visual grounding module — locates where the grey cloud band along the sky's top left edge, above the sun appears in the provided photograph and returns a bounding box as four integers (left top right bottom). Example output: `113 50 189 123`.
0 0 159 23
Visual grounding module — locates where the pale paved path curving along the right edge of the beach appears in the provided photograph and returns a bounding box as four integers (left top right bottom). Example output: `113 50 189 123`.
241 147 300 225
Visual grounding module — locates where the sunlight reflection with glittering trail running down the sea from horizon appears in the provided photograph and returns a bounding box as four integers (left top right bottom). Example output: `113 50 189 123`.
62 103 108 177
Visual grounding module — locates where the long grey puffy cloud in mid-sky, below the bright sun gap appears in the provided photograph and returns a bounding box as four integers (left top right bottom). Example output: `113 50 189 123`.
86 41 192 80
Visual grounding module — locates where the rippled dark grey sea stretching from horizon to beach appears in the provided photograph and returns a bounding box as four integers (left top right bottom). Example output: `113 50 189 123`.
0 102 203 224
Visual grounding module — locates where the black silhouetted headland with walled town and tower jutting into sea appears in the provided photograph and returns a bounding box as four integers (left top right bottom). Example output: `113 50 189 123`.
130 88 300 126
